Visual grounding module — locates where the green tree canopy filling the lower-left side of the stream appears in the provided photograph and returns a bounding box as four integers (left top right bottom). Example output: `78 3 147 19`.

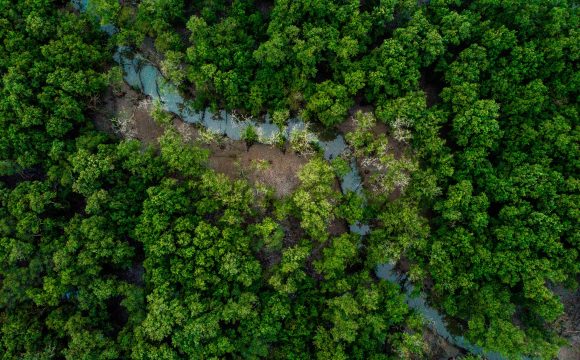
0 2 421 359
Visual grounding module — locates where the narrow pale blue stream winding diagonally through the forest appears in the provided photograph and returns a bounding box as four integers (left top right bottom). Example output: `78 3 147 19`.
71 0 504 360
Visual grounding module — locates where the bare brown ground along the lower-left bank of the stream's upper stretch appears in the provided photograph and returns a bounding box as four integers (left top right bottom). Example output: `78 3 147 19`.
93 84 308 198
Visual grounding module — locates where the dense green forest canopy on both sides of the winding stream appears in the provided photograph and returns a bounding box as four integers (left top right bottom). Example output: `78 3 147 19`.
0 0 580 359
